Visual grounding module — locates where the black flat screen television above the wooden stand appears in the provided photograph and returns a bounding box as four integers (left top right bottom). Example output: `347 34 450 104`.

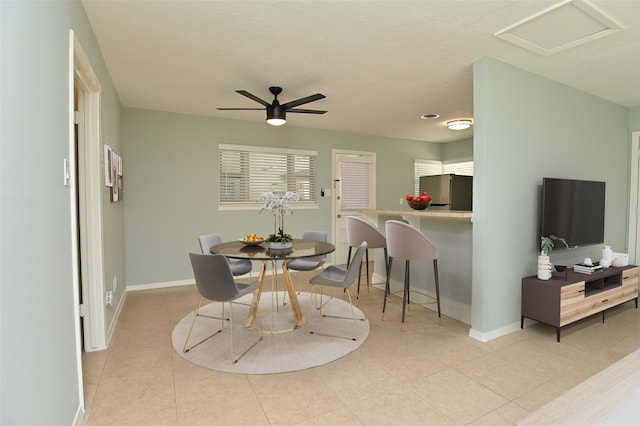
541 177 606 249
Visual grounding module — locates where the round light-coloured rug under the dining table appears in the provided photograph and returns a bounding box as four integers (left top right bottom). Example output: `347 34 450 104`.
171 291 369 374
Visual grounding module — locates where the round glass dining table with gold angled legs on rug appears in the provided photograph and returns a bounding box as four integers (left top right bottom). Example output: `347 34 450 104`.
211 239 335 333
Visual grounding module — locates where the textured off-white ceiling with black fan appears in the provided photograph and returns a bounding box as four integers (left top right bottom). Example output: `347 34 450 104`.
82 0 640 142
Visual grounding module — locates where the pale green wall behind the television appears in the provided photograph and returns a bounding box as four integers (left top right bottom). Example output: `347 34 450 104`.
472 59 629 334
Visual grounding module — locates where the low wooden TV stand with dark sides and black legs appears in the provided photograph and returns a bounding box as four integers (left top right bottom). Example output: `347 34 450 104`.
520 265 638 342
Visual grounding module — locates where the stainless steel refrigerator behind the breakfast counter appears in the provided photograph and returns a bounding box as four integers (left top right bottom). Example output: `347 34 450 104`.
420 174 473 211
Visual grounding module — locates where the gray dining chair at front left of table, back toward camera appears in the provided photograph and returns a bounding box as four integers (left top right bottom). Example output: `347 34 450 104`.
182 253 263 364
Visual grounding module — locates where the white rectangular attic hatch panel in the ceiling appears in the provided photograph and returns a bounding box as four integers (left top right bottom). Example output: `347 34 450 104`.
494 0 622 56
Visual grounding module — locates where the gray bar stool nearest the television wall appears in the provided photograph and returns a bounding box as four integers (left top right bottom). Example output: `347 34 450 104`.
382 220 441 325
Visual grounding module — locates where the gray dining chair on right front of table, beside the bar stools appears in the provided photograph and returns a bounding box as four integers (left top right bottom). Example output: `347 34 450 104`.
307 241 367 340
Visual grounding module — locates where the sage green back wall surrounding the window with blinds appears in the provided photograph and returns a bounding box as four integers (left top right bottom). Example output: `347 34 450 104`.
123 109 450 286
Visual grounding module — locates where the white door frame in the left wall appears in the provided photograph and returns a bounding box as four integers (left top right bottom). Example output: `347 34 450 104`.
70 30 106 352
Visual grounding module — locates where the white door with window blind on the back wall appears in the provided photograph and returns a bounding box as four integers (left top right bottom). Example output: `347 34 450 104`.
333 150 376 265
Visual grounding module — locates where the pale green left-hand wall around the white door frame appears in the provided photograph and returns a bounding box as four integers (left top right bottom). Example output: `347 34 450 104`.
0 0 124 425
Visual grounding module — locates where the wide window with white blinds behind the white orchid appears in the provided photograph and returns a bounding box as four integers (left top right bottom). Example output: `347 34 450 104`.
218 144 318 208
